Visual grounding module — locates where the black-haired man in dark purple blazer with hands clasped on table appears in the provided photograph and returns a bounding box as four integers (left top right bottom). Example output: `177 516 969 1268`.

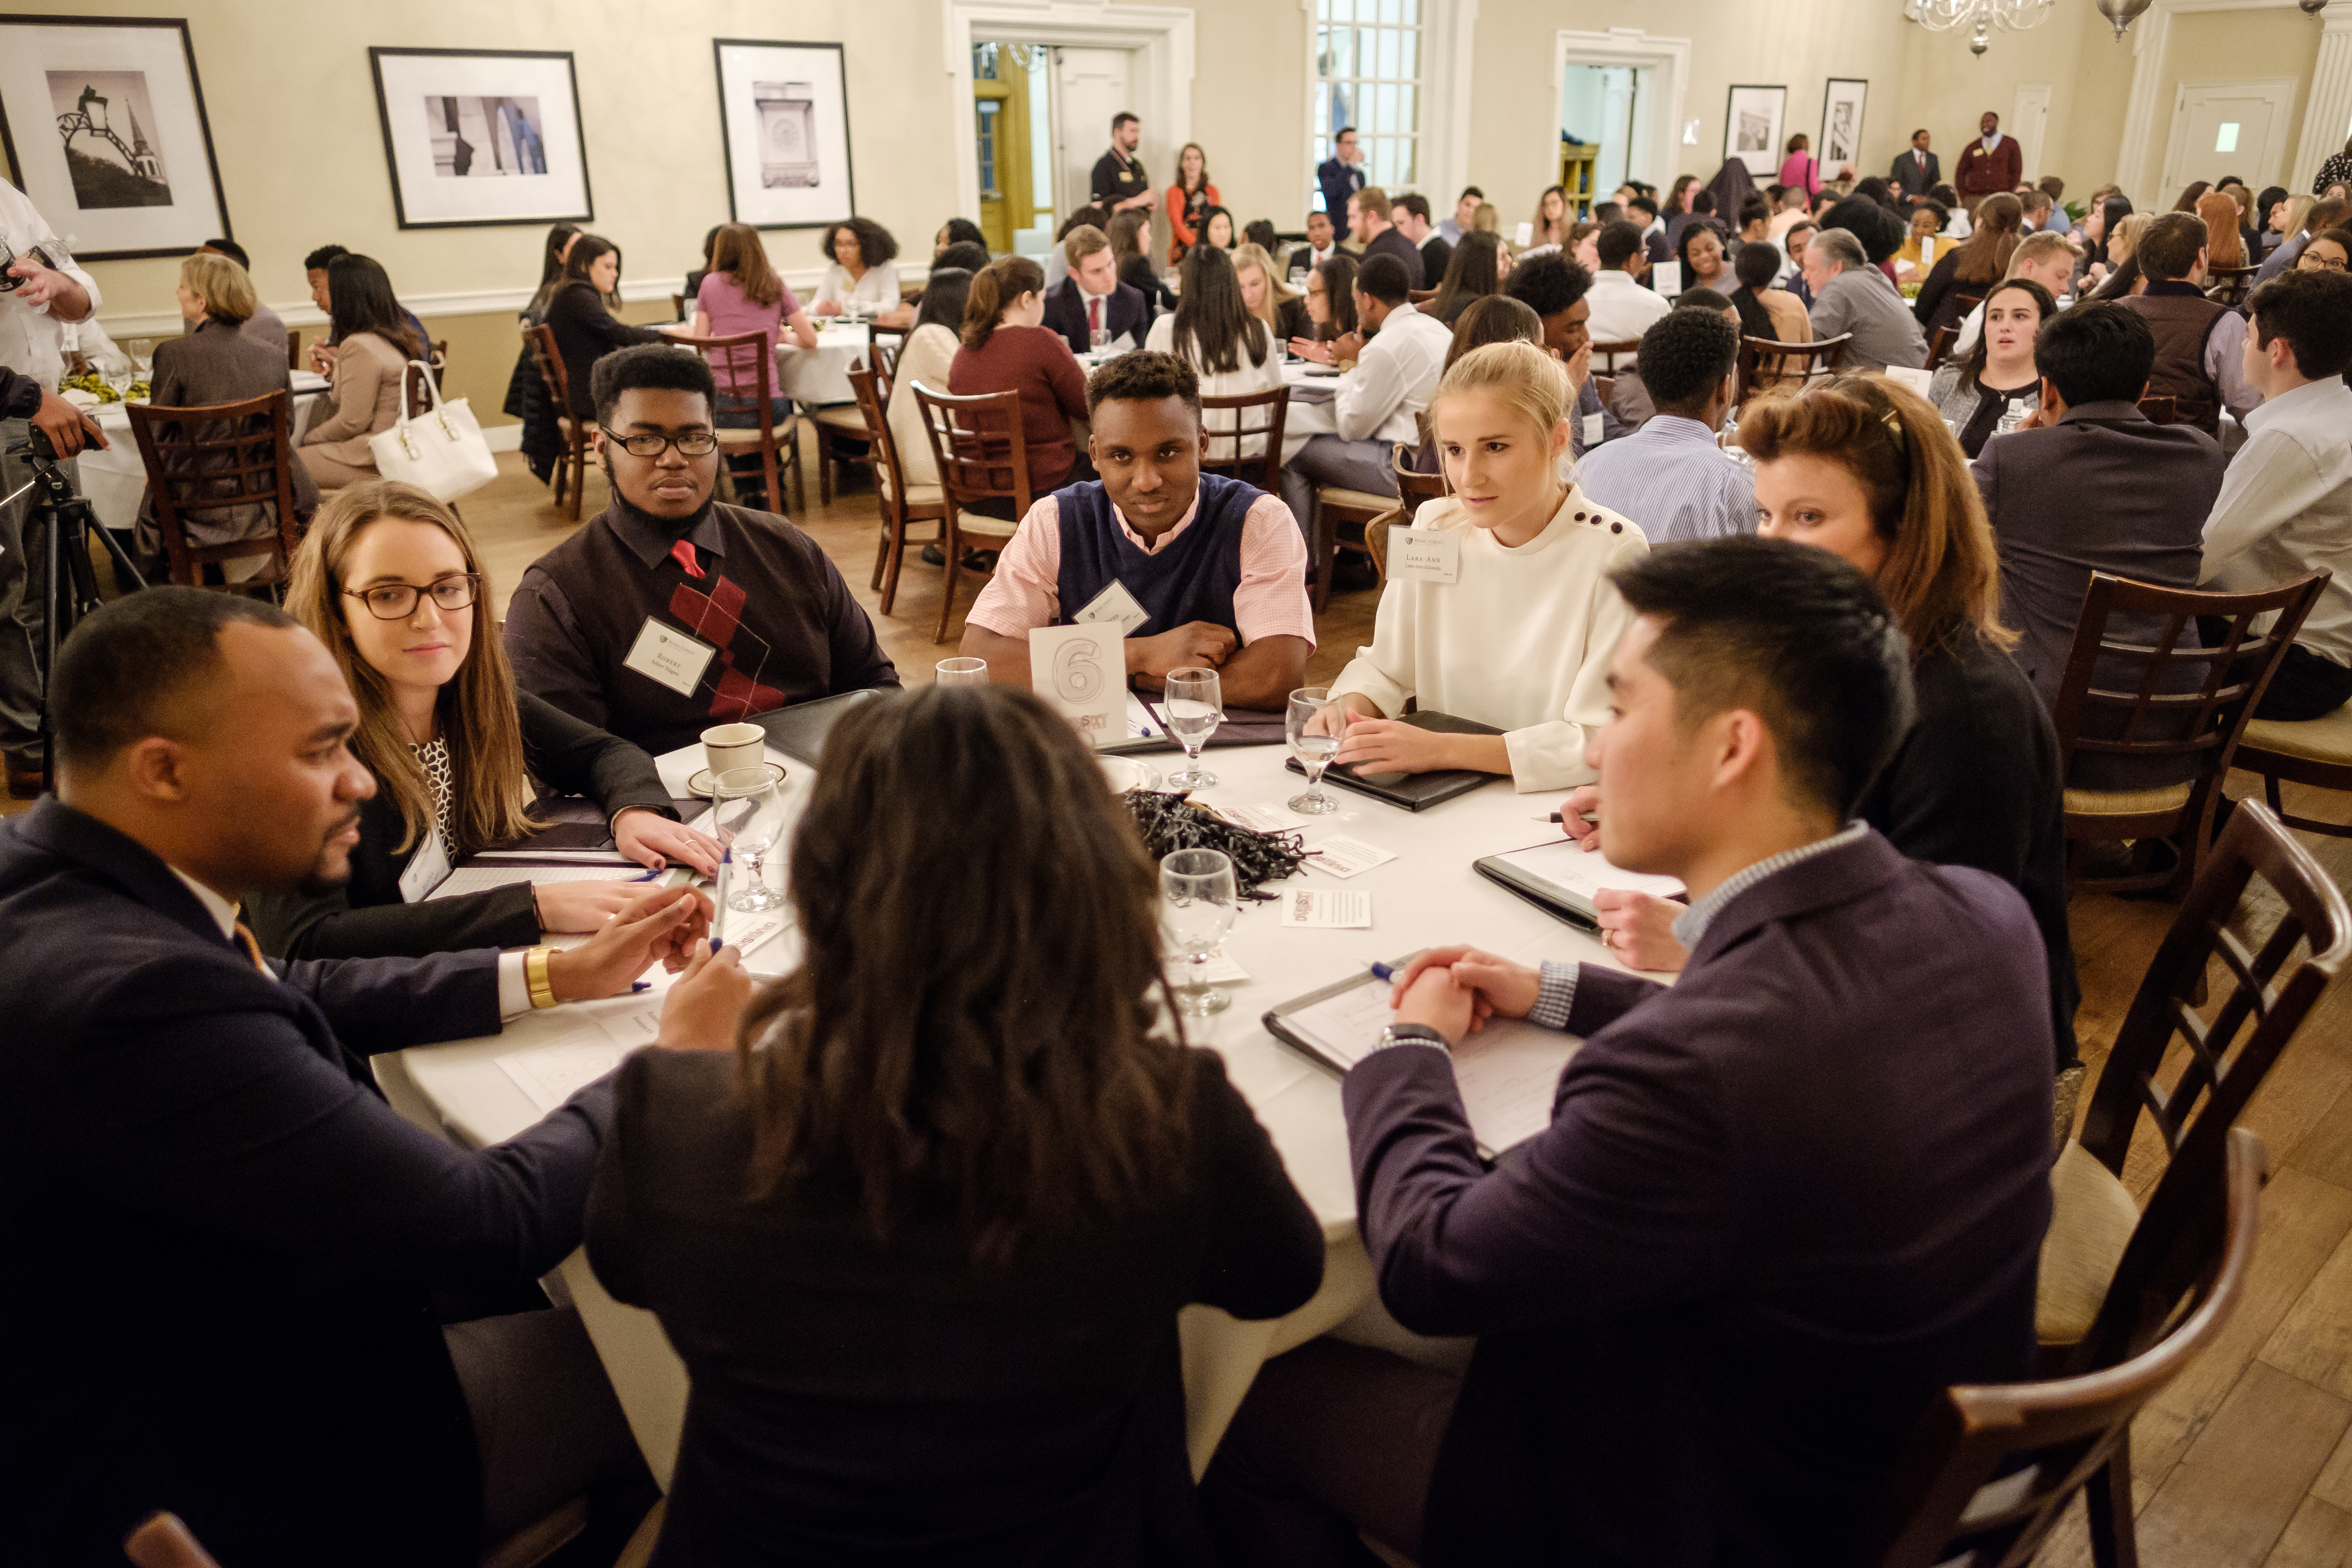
1207 538 2053 1568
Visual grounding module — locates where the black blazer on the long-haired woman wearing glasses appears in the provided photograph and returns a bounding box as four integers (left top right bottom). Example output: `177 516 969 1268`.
245 691 677 959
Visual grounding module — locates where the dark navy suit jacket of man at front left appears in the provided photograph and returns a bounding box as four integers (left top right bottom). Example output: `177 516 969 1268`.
0 799 612 1568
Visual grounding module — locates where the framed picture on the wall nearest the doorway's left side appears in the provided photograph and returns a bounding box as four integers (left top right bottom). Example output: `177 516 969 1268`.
713 38 856 228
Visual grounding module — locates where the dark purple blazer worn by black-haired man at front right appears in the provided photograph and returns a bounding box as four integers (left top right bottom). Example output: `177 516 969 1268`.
1343 832 2051 1568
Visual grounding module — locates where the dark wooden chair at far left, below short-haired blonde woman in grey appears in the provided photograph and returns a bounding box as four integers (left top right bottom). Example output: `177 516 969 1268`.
122 388 301 588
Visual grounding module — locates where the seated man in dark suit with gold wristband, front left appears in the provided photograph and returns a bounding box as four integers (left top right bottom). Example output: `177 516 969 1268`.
0 588 748 1568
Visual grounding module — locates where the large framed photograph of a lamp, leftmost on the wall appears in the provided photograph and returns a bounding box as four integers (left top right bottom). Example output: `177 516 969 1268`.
0 16 233 261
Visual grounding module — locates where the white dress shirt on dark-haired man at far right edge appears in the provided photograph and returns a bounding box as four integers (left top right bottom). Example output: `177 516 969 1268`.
2201 376 2352 665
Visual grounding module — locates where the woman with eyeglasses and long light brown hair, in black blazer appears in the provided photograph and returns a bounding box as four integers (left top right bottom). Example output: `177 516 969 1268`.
247 479 720 959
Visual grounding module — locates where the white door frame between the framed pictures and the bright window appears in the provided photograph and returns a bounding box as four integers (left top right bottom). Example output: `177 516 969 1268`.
941 0 1192 230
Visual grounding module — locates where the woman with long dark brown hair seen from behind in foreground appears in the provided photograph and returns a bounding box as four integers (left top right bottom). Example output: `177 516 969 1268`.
588 686 1324 1568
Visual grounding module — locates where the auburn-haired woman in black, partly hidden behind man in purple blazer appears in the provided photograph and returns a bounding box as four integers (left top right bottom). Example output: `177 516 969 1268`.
1562 374 2082 1067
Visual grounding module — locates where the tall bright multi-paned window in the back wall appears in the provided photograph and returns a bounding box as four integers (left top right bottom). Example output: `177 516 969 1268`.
1310 0 1435 205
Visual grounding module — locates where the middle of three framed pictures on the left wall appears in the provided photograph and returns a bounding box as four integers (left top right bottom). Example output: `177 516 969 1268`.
367 49 595 228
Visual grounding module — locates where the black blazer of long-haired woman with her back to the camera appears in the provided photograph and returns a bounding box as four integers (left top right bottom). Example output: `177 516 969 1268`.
588 1034 1327 1568
